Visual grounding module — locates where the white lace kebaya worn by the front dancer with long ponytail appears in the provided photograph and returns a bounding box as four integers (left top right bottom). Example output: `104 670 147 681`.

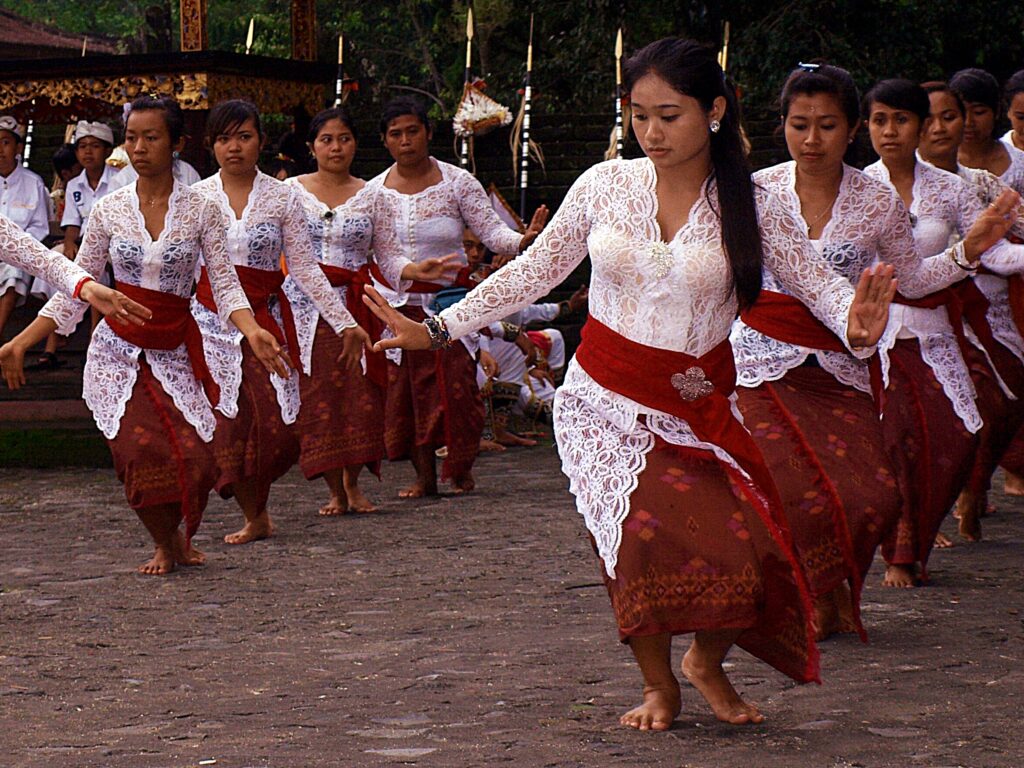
441 159 853 578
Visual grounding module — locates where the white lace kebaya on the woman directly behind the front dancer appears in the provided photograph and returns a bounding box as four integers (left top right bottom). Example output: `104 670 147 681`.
731 161 964 393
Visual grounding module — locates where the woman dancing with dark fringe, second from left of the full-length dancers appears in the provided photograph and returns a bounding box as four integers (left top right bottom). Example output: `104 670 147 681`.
193 99 369 544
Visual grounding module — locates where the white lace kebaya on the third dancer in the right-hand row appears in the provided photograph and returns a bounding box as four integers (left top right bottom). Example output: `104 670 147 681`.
864 161 1024 432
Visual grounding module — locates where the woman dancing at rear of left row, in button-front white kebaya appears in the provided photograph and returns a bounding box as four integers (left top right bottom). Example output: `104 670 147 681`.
367 97 548 498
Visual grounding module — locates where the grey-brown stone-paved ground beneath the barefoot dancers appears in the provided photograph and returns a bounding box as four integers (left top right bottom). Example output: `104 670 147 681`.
0 449 1024 768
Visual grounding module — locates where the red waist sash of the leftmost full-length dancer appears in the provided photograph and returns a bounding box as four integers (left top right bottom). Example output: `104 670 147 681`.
105 283 220 407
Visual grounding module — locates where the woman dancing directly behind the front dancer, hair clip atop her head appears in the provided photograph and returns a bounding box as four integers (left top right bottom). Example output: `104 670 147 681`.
732 65 964 639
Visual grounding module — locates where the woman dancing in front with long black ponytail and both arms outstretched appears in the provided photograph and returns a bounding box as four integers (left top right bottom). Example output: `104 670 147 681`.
368 39 895 730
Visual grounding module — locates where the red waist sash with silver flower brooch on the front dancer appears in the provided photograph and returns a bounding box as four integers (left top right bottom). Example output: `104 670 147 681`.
575 317 788 528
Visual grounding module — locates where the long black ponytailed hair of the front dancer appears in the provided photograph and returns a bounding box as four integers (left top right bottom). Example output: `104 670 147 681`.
623 38 762 309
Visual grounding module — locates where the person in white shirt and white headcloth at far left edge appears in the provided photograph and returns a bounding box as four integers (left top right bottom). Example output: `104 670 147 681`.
0 115 50 342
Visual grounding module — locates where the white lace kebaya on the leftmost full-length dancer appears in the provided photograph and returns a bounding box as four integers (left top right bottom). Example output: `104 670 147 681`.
40 181 250 442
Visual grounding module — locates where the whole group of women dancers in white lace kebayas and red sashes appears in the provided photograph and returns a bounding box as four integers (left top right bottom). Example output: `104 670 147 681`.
0 34 1024 730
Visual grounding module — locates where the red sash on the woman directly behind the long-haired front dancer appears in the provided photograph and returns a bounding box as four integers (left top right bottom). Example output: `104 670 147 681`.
739 291 885 414
